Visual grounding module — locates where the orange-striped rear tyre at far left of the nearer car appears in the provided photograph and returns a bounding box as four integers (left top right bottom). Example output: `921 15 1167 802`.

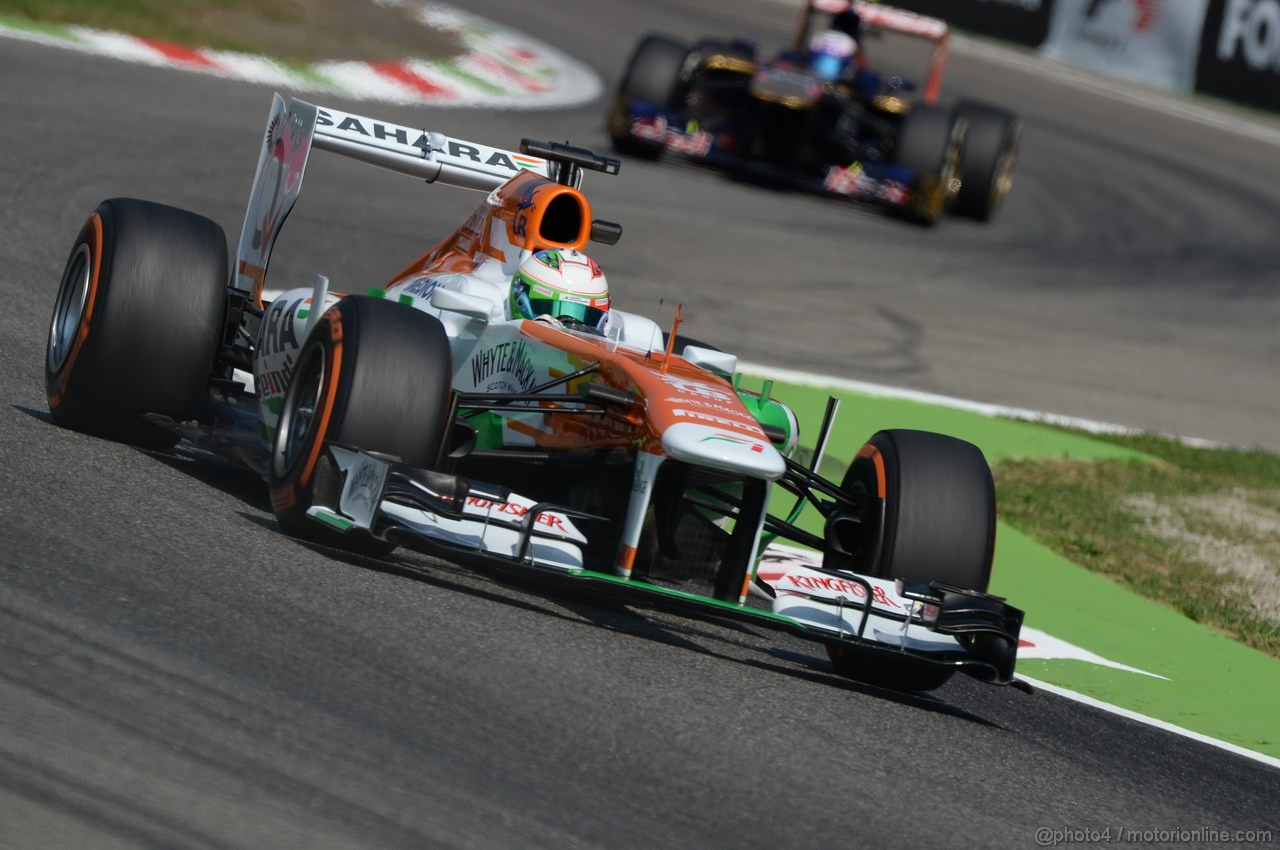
45 198 228 448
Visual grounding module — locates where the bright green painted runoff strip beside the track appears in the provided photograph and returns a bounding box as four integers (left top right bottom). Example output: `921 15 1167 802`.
742 378 1280 757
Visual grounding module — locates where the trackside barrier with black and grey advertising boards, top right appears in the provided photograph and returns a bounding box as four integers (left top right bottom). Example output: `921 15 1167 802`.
888 0 1280 111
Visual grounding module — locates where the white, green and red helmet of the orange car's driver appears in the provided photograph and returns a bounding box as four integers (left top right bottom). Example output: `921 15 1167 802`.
511 248 609 330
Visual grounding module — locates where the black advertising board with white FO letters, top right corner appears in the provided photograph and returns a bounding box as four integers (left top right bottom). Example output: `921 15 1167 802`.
1196 0 1280 110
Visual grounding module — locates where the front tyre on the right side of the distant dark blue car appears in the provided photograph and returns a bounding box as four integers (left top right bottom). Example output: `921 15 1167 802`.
893 106 966 227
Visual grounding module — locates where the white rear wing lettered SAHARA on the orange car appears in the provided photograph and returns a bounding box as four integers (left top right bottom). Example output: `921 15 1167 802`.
233 95 570 303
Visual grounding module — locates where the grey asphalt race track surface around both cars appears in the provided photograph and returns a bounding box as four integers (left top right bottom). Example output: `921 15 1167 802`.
0 0 1280 850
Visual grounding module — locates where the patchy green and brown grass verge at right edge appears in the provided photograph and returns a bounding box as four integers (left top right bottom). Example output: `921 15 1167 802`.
995 435 1280 657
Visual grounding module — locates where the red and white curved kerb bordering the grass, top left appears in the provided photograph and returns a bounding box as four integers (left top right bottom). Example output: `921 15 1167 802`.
0 0 603 109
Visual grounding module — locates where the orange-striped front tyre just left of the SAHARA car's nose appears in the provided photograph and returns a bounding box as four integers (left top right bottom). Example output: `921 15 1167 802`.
269 296 453 556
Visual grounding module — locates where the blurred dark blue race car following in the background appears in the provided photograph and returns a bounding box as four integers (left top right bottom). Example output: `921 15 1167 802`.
608 0 1021 224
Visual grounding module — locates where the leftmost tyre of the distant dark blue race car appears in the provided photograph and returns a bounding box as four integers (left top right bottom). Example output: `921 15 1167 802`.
608 35 689 159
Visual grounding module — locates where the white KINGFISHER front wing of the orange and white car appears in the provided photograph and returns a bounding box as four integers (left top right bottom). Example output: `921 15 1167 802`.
308 444 1023 685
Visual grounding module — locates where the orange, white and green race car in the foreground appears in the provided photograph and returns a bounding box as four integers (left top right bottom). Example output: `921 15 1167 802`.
46 96 1021 690
